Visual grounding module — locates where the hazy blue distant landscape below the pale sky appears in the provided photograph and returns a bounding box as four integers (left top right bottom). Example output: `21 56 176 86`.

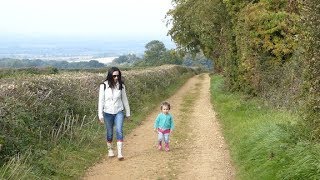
0 34 174 61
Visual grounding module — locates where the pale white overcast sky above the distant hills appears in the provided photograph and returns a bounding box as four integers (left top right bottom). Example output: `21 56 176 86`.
0 0 172 36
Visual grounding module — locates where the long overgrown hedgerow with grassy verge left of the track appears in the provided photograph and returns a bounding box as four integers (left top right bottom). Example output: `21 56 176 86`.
0 66 197 179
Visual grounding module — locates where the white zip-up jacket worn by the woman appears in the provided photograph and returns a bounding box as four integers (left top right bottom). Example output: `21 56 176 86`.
98 81 130 119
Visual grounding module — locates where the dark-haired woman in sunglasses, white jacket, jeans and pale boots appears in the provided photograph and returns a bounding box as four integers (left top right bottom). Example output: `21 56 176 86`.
98 67 130 160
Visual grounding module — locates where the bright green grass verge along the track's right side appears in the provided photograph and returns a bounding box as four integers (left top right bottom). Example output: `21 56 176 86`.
211 76 320 180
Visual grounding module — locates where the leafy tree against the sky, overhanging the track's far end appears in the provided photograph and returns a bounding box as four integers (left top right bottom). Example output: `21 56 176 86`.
167 0 232 71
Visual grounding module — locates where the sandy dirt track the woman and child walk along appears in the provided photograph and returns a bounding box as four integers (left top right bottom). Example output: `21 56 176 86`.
83 74 235 180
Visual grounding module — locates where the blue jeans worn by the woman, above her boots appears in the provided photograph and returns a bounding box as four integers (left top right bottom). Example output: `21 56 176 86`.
104 111 124 142
